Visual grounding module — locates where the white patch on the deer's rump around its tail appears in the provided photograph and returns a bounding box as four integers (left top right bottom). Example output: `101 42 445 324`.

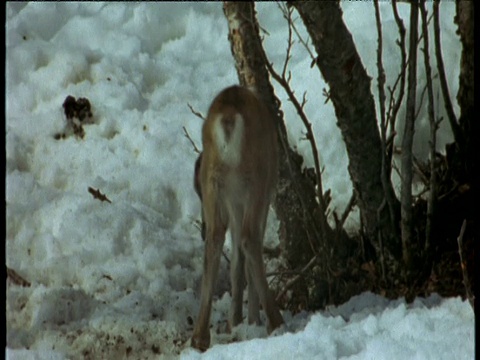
213 114 244 167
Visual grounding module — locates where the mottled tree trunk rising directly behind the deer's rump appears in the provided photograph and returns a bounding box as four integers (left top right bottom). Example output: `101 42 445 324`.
223 1 332 308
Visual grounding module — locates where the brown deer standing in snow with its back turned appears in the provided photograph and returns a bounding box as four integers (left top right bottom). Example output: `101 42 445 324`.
191 86 284 352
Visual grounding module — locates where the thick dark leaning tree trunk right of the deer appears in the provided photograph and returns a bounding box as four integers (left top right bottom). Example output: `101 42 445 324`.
291 1 401 276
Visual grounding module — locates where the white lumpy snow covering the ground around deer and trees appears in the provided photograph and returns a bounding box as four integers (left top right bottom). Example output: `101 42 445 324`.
5 2 474 359
